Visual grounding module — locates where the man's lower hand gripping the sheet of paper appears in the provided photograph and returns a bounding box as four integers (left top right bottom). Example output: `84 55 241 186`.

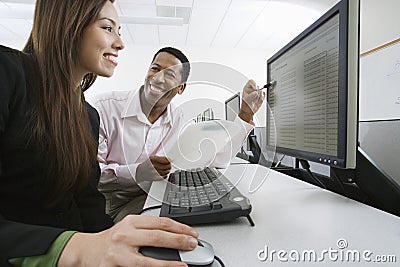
136 156 171 184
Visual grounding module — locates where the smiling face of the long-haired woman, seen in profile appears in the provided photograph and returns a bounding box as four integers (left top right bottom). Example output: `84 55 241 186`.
77 1 124 79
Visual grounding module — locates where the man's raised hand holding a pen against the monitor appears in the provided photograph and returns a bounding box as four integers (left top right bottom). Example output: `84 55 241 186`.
239 80 265 123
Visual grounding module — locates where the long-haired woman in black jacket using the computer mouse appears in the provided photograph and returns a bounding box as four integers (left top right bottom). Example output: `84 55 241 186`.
0 0 198 267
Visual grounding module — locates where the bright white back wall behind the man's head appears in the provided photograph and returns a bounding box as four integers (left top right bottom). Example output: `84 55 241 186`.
86 46 271 126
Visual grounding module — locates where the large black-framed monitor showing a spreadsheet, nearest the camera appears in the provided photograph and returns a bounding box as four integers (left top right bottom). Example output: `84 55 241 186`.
266 0 359 168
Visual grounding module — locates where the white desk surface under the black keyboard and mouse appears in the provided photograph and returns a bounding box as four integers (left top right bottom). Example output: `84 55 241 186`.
145 164 400 267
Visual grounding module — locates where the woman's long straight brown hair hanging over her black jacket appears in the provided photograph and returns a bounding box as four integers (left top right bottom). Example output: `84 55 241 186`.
23 0 114 206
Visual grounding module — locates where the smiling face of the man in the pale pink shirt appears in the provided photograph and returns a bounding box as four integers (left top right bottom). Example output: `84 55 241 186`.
143 52 185 109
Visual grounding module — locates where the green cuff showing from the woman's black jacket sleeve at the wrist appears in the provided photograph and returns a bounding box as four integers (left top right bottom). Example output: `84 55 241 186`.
9 231 76 267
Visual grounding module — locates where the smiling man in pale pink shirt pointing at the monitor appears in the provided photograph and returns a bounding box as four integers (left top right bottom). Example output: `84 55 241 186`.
90 47 265 222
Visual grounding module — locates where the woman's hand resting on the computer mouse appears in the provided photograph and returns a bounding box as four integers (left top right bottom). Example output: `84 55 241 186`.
57 215 198 267
